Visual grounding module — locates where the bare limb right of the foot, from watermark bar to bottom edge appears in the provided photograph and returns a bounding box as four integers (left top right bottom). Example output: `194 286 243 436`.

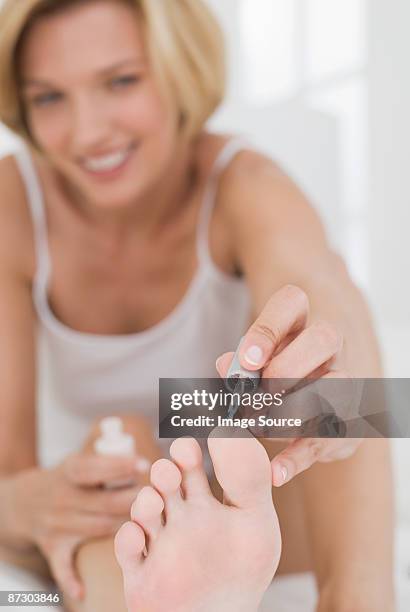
300 439 394 612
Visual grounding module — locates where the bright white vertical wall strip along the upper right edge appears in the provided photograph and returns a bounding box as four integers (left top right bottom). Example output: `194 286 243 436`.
368 0 410 330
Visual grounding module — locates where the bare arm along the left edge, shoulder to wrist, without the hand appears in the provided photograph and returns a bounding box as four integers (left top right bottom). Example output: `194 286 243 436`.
0 158 36 547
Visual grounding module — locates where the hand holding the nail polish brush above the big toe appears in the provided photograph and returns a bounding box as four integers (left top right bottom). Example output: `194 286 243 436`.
216 285 361 486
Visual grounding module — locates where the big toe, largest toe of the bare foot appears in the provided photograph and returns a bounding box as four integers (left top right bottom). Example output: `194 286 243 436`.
208 429 272 508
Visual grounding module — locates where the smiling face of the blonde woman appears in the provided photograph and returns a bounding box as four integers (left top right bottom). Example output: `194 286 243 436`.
20 0 178 209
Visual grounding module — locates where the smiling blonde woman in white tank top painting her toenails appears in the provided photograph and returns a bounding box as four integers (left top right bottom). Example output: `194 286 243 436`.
0 0 393 612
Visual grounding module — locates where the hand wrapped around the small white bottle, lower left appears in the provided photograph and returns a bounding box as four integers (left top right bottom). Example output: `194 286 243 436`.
15 453 139 599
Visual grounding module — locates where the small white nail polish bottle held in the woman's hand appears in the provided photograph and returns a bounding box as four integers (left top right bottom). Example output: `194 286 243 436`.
94 417 137 489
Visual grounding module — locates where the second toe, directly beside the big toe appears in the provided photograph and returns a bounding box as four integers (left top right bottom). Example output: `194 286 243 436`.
170 438 211 500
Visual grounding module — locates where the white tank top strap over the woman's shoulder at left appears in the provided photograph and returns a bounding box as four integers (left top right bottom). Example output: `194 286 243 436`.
14 146 50 292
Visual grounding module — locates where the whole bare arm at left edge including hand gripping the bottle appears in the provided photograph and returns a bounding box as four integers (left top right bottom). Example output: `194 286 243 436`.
0 159 162 609
